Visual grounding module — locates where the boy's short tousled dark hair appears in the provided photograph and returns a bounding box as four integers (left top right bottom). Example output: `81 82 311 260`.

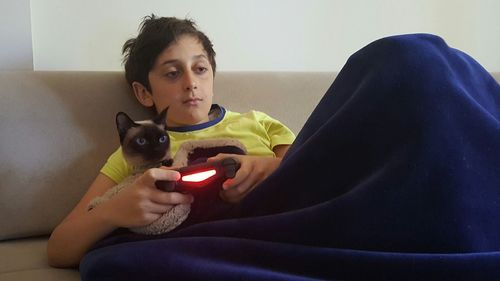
122 14 216 91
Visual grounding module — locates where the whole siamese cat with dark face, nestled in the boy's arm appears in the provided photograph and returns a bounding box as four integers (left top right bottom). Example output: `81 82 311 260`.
87 108 191 234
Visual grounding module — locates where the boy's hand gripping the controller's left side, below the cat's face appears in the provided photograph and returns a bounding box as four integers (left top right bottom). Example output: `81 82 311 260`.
98 168 193 227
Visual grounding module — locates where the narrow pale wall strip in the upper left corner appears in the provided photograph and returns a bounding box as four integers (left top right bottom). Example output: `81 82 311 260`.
0 0 33 70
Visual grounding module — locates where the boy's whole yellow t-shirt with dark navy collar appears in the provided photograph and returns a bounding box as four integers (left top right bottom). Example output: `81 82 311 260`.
101 105 295 183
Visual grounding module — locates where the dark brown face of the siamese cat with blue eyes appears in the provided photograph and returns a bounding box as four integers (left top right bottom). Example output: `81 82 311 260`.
116 109 170 167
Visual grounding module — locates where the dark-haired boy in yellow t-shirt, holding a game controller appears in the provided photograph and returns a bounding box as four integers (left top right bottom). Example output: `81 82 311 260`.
47 15 294 267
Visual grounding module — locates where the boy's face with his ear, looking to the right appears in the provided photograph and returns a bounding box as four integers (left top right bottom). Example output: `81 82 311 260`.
134 35 214 127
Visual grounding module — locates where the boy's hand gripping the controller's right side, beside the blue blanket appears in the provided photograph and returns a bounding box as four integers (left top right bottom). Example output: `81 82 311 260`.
208 153 281 203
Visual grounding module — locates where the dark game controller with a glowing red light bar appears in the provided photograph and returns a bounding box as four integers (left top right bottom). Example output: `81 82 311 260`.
156 158 240 193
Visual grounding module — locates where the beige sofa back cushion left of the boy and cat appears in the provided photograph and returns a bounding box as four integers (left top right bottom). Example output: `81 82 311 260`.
0 72 143 240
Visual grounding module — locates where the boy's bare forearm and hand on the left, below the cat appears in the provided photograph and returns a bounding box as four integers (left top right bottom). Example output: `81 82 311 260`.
47 168 193 267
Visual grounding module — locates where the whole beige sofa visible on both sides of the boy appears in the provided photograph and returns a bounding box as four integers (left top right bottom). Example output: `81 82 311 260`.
0 72 335 281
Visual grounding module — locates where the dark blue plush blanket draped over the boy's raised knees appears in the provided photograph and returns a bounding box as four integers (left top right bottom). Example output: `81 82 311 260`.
80 34 500 280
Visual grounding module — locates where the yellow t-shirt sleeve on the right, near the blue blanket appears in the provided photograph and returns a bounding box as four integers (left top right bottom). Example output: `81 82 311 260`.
255 111 295 149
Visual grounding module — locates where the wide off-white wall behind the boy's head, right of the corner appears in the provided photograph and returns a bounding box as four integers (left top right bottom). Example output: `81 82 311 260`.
31 0 500 71
